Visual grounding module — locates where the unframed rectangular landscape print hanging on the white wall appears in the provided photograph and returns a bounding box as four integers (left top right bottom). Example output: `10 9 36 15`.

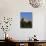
20 12 32 28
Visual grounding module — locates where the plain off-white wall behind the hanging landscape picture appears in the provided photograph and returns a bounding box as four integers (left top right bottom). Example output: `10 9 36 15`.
0 0 46 40
